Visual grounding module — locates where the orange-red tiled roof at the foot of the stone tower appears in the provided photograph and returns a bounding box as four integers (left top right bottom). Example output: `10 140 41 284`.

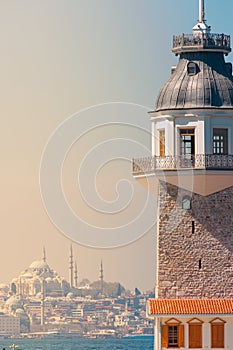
149 299 233 315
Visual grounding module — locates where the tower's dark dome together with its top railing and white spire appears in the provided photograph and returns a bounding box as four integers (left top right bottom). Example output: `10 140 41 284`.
155 2 233 112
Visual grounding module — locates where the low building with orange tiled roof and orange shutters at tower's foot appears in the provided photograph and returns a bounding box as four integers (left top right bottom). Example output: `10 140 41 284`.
149 299 233 350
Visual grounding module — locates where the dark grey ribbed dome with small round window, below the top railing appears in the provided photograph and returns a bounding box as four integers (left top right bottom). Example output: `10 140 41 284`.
155 51 233 111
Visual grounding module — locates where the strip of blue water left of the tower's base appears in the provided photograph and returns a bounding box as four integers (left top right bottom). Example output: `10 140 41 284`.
0 338 153 350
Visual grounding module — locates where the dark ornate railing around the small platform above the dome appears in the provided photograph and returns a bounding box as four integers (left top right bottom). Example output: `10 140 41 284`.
172 33 231 53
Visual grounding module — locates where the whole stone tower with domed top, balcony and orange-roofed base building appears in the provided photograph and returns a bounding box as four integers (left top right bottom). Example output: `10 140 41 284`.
133 0 233 350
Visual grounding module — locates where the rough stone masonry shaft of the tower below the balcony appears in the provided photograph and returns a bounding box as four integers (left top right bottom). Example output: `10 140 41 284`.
158 182 233 298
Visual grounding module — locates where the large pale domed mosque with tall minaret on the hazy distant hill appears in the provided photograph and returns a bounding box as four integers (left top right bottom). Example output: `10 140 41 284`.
10 246 78 298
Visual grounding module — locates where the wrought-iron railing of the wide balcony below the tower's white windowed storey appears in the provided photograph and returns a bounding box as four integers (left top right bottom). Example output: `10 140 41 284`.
133 154 233 174
